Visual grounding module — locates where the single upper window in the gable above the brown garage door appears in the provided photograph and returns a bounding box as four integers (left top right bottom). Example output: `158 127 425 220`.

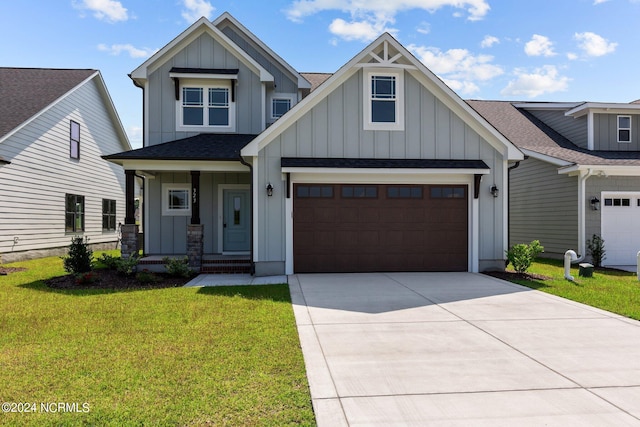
364 71 404 130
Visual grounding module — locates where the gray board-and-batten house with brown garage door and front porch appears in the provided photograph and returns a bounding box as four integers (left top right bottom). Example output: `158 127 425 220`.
105 13 524 275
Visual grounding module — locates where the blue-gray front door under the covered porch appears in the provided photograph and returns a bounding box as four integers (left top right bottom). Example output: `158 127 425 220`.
222 190 251 252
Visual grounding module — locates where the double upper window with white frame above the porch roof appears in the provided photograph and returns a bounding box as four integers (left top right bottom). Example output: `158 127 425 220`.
177 81 235 132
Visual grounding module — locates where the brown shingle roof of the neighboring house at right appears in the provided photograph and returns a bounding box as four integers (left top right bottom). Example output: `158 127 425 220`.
467 100 640 166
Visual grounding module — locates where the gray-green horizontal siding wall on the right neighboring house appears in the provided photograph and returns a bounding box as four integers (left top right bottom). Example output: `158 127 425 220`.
509 158 579 258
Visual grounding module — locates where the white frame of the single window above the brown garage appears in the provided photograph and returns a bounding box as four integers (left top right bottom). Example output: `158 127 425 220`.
363 69 404 131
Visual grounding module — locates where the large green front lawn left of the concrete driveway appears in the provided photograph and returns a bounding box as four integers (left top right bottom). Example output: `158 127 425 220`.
0 253 315 426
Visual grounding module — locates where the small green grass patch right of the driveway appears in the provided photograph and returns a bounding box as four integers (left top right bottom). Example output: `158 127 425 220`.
504 259 640 320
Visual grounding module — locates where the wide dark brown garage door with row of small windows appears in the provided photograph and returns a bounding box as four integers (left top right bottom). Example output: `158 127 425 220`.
293 184 468 273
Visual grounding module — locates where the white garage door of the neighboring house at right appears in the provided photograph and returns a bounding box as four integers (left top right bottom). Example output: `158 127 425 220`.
600 192 640 266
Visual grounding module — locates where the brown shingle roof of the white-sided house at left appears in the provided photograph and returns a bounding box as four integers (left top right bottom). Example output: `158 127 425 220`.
0 67 97 137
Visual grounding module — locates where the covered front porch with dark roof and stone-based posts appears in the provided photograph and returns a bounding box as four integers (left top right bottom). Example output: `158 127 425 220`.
105 134 255 274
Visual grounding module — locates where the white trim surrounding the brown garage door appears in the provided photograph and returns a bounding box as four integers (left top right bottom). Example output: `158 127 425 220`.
286 170 480 274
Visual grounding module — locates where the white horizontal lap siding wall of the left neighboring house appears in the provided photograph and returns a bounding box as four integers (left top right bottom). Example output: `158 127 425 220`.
0 80 125 258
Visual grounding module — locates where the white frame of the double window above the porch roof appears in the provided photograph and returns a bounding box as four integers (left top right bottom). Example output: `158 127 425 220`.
176 79 236 132
